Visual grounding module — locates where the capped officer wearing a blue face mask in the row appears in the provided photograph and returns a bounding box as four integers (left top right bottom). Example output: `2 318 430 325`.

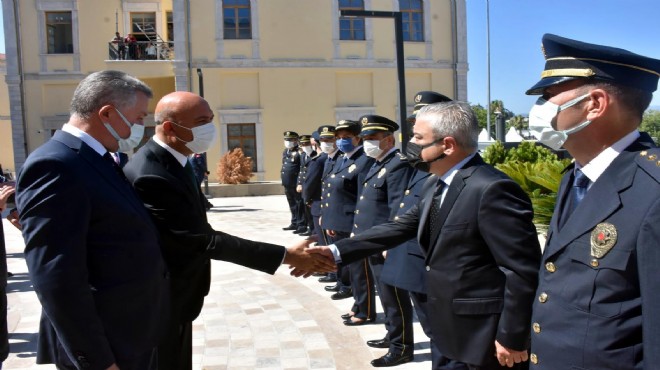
321 120 376 304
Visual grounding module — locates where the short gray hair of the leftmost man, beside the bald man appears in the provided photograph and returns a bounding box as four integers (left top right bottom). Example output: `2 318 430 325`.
71 71 153 118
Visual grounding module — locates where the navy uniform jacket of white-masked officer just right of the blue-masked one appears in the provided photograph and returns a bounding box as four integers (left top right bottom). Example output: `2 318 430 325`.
353 149 413 234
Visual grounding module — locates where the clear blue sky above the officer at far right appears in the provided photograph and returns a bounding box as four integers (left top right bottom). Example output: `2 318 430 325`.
0 0 660 115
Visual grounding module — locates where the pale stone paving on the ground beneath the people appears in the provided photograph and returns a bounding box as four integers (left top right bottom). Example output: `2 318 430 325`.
3 195 431 370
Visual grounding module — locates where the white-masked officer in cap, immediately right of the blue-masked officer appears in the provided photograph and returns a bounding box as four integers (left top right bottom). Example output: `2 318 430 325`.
351 115 414 367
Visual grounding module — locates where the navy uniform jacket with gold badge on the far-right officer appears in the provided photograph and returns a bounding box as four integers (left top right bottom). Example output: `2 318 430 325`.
531 138 660 370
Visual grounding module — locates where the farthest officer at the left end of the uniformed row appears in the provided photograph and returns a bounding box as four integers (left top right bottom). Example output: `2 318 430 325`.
281 131 307 232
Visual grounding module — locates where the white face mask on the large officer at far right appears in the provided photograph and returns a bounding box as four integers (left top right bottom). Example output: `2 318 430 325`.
529 94 591 150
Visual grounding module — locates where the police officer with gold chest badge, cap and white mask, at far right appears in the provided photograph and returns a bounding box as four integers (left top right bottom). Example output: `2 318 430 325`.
527 34 660 370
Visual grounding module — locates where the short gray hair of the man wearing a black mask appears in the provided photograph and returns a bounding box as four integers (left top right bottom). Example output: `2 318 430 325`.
416 101 479 150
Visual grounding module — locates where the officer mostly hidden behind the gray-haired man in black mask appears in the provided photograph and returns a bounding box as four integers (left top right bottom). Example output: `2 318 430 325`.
378 91 451 369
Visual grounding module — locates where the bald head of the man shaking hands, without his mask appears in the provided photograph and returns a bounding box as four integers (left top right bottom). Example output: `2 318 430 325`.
154 91 213 155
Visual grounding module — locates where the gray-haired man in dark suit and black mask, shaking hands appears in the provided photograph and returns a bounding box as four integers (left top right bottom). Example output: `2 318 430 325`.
306 102 541 369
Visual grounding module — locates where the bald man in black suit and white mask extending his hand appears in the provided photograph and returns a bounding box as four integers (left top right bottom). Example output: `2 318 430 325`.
124 91 334 370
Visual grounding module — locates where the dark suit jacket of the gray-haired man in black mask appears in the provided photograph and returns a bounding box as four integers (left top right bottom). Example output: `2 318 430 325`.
336 154 541 365
